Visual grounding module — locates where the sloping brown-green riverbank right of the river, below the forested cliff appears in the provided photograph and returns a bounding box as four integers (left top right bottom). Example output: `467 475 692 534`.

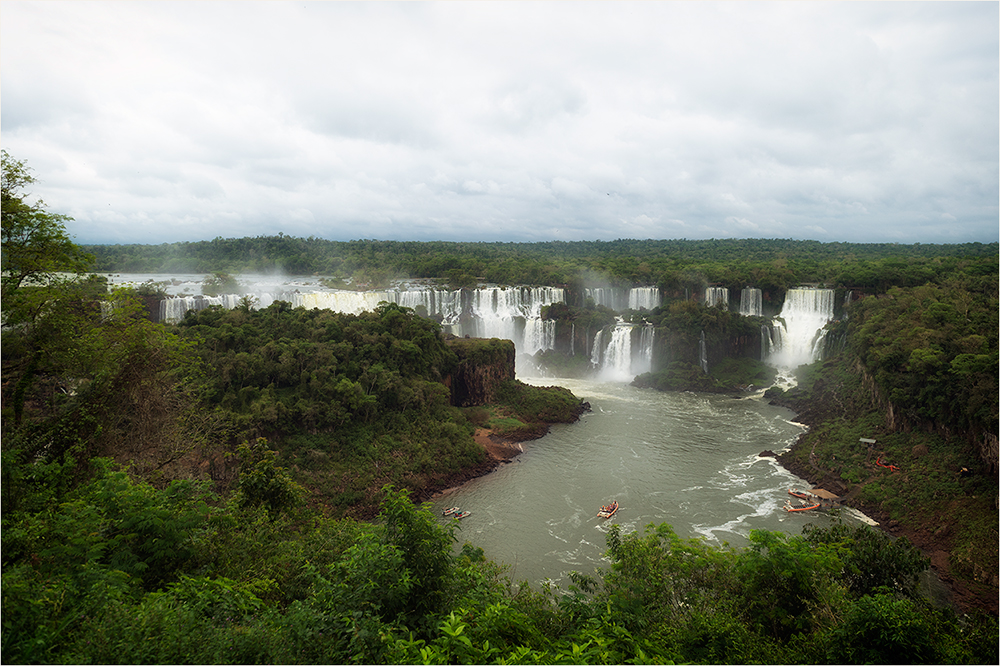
772 360 998 615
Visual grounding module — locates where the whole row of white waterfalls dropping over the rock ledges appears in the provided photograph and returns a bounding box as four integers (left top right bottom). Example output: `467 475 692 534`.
146 279 834 383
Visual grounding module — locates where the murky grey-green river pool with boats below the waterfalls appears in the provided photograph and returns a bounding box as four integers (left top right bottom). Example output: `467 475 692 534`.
433 377 863 586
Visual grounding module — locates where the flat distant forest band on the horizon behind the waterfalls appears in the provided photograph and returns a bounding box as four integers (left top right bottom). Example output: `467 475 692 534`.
83 235 998 293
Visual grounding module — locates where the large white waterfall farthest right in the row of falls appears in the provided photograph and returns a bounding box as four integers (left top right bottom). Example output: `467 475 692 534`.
768 288 834 369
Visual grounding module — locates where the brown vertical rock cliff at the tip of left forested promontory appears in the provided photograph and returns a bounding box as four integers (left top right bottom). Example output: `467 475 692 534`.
445 338 515 407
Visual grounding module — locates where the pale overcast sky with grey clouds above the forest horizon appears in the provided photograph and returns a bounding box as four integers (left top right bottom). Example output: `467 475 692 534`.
0 0 1000 243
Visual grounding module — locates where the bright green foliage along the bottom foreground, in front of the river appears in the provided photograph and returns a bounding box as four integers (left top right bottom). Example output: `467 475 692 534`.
2 474 997 664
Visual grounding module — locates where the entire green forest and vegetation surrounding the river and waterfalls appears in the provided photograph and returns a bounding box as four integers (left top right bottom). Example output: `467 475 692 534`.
0 153 998 663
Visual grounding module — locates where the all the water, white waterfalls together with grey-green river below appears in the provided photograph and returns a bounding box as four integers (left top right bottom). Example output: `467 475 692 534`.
101 274 870 585
